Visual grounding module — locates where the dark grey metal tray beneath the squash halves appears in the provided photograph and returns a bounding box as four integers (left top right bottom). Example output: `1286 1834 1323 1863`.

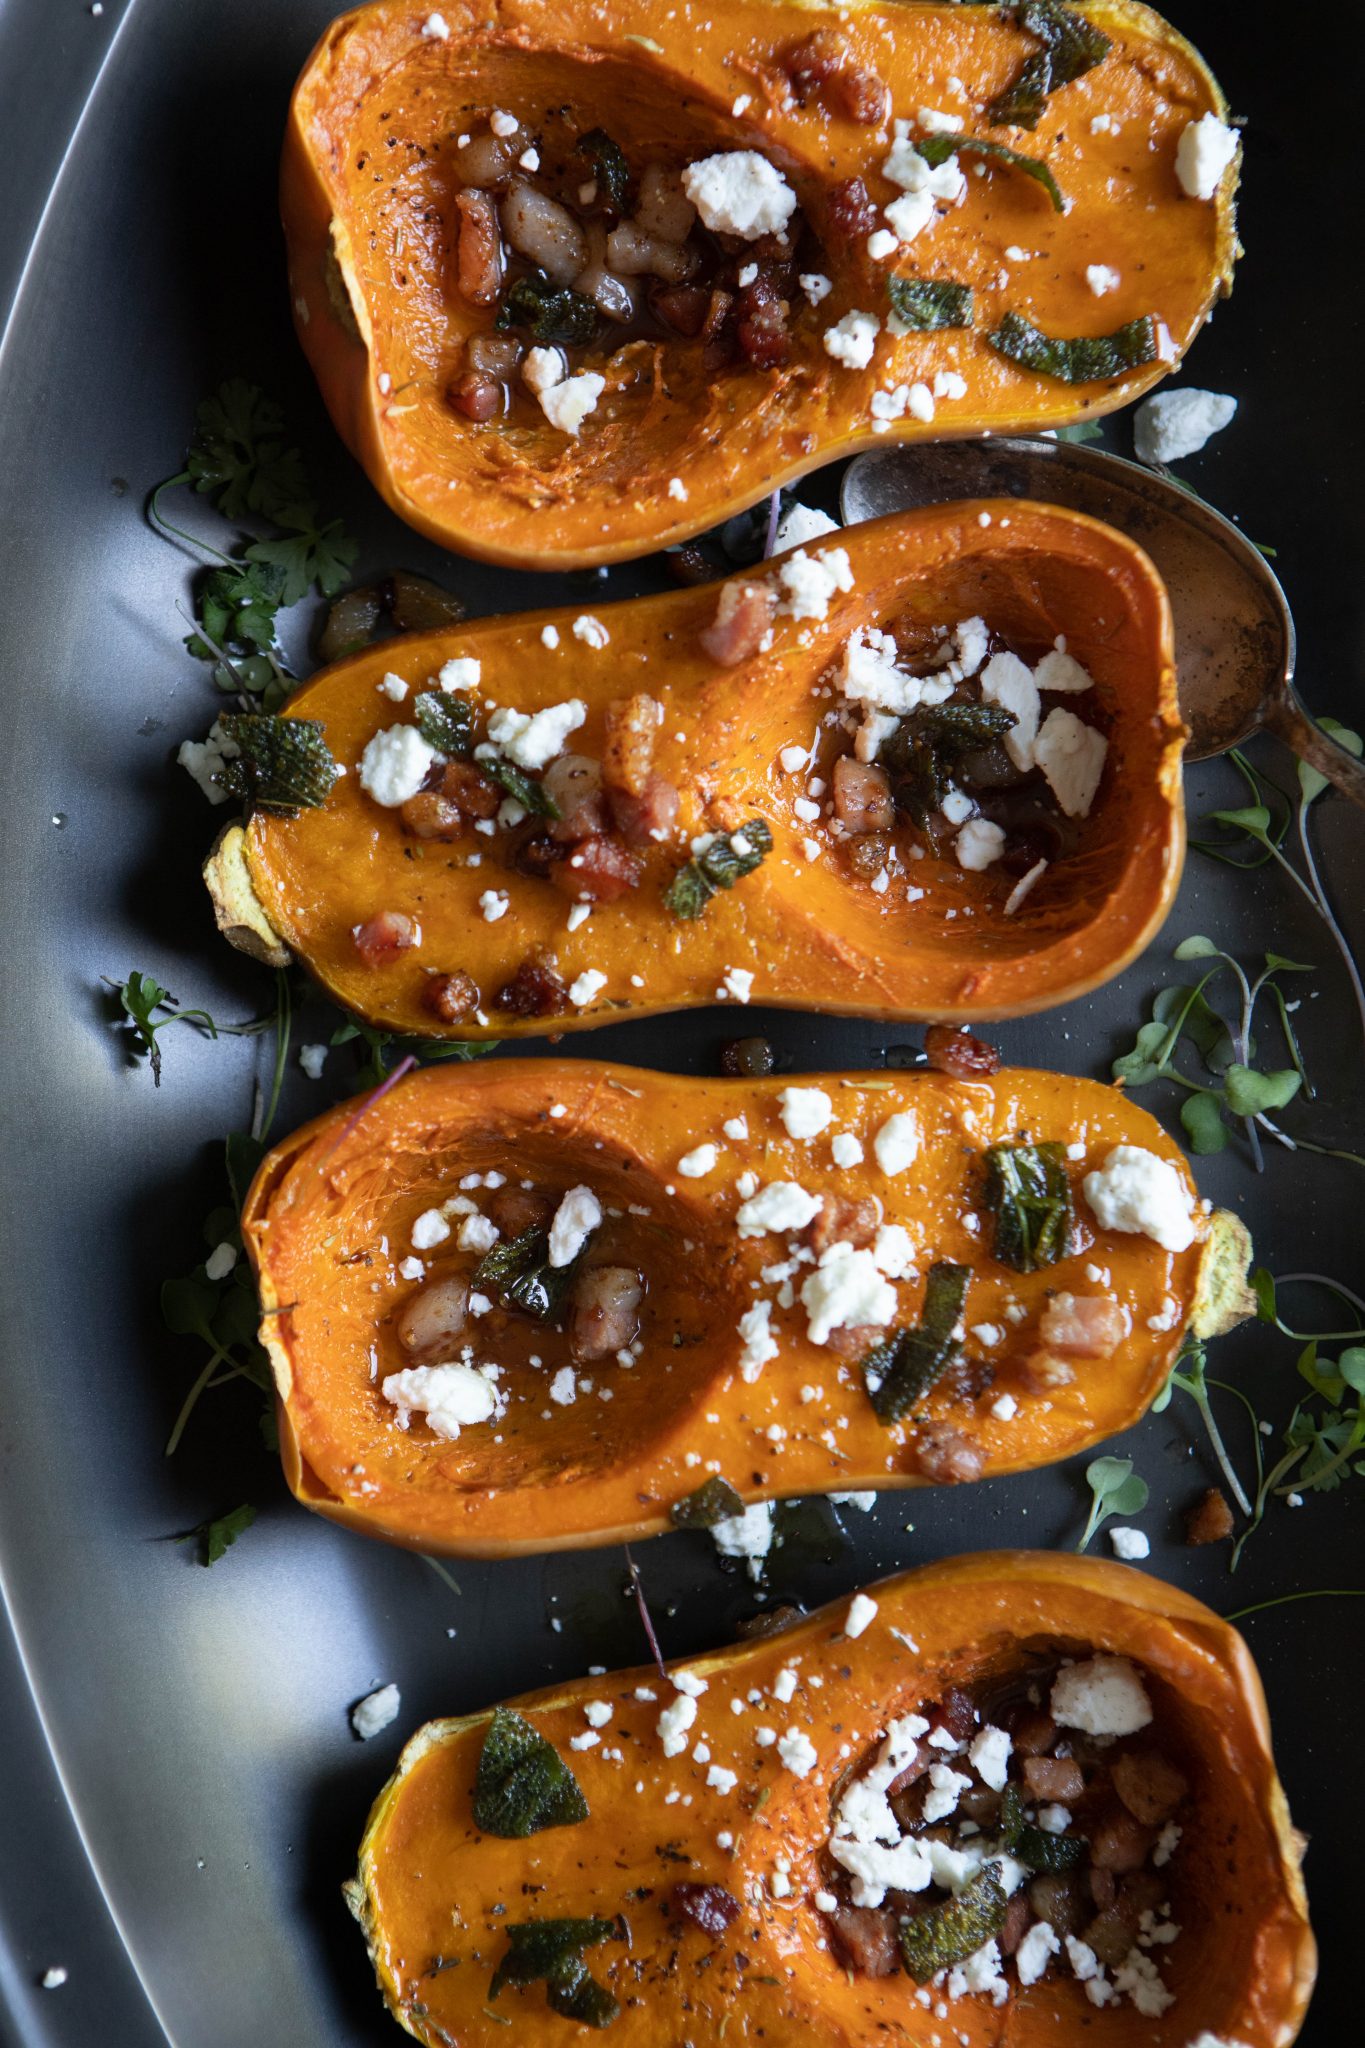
0 0 1365 2048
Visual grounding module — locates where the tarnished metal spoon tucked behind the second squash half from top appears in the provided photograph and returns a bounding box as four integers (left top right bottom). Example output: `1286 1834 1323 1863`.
841 438 1365 807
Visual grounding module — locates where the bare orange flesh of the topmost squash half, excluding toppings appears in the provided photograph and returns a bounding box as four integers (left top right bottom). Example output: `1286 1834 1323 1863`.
280 0 1238 569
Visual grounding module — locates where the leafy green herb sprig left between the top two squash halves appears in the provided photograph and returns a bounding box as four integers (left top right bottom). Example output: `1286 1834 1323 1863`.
147 377 356 711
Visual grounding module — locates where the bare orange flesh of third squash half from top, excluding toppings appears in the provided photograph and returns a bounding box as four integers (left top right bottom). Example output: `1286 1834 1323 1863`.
241 1059 1252 1556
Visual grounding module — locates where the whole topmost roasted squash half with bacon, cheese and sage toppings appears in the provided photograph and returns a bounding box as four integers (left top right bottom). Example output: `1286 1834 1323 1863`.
280 0 1238 567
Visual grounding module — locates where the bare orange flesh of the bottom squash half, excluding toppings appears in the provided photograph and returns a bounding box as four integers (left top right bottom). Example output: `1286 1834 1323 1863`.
346 1550 1316 2048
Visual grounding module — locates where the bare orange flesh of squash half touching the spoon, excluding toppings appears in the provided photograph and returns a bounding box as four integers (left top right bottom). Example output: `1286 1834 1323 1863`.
207 500 1185 1038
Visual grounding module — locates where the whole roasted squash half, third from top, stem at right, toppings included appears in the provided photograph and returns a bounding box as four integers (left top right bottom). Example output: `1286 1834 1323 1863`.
244 1059 1252 1556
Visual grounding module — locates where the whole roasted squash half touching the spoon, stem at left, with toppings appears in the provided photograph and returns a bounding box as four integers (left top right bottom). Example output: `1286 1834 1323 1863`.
207 500 1185 1038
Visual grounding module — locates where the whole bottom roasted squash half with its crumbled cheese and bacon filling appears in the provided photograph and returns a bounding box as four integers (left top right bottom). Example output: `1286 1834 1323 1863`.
346 1550 1316 2048
